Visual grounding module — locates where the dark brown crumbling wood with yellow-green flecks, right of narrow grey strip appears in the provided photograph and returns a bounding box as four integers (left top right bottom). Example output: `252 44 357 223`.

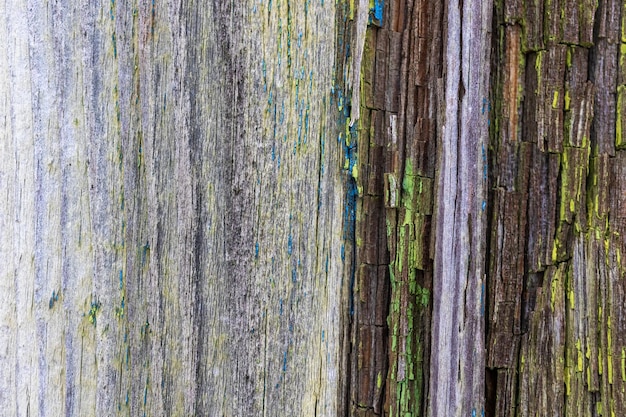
487 0 626 416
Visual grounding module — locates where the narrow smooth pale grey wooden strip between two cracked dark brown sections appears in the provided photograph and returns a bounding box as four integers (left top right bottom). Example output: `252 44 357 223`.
428 1 493 415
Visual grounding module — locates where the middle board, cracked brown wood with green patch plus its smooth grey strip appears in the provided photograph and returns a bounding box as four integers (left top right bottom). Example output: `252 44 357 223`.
351 1 491 416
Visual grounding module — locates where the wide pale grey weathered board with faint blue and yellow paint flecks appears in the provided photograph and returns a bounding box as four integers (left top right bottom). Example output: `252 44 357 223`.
0 0 350 416
